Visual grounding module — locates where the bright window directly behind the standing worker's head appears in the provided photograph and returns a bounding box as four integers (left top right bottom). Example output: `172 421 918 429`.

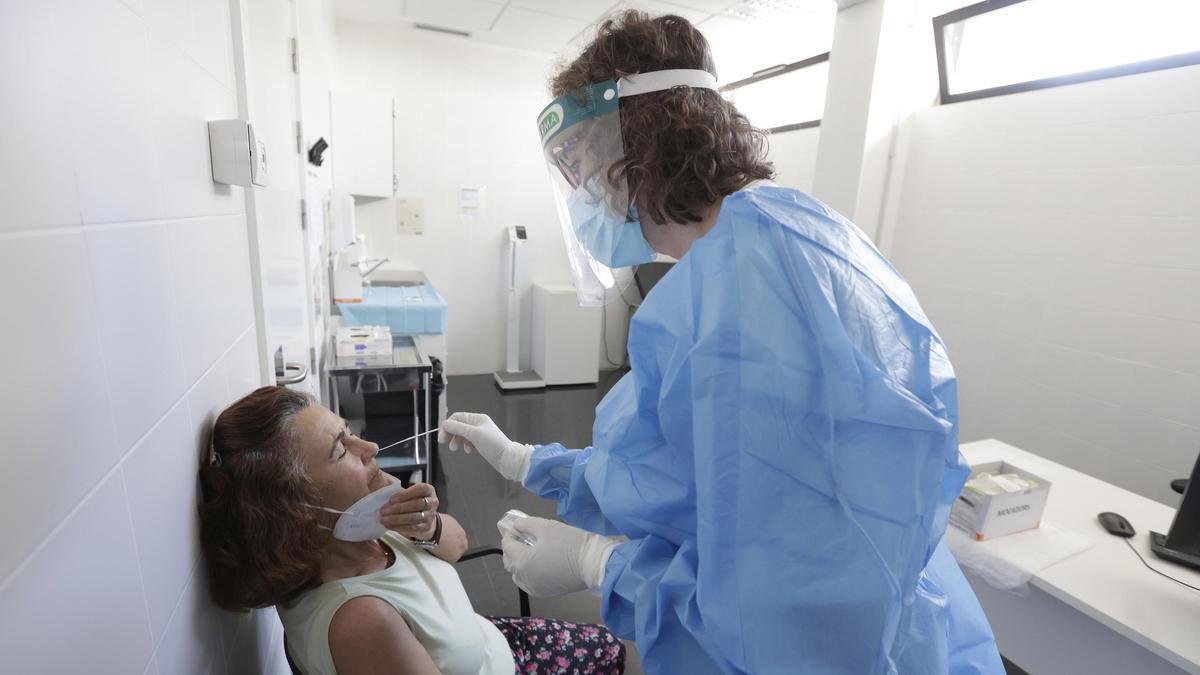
721 52 829 133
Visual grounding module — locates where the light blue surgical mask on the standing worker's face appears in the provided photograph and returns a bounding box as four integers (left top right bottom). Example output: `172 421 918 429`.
566 187 656 269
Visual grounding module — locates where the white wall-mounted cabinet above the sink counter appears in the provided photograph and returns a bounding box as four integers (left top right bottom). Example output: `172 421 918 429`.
330 91 396 197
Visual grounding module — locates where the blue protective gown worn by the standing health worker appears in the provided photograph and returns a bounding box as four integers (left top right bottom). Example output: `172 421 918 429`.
526 185 1003 675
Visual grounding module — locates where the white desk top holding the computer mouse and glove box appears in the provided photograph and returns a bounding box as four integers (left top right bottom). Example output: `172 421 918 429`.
961 440 1200 674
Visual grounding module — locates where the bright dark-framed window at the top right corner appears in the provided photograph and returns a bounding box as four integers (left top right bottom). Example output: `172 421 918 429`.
934 0 1200 103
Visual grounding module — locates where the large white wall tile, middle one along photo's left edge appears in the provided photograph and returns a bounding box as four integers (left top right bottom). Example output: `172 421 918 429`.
0 229 120 580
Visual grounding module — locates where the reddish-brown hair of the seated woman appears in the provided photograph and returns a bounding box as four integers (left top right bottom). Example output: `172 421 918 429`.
199 387 328 610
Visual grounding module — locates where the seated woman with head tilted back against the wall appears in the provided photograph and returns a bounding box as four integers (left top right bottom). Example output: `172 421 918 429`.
200 387 625 675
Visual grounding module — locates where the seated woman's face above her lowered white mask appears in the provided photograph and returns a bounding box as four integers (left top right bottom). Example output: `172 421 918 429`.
295 406 389 510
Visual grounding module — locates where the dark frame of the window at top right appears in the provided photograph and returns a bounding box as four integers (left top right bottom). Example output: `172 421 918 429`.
934 0 1200 106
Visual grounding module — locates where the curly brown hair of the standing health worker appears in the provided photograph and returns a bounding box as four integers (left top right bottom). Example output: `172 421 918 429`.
550 10 775 223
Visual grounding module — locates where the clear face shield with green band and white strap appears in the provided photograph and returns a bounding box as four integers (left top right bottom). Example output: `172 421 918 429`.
538 70 716 306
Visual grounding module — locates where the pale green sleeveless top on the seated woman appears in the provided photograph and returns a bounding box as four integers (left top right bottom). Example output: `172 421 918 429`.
277 532 516 675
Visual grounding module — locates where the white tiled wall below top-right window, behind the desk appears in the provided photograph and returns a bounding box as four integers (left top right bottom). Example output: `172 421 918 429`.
893 66 1200 504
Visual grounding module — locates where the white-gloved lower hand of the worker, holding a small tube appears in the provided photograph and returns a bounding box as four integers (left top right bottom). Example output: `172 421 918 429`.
500 518 620 598
